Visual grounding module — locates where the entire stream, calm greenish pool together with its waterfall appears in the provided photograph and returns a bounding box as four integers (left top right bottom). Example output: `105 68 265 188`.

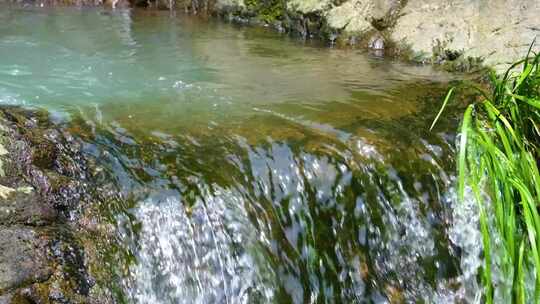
0 5 481 303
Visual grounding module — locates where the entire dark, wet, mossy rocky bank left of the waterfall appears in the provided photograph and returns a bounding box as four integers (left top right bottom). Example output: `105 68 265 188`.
0 107 108 304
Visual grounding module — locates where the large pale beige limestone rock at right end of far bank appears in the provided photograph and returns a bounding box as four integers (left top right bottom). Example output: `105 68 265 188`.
391 0 540 66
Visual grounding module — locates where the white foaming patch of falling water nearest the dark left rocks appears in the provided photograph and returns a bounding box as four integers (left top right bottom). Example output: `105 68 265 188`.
122 189 273 303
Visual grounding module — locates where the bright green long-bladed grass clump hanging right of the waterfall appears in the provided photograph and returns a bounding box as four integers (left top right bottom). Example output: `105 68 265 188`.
432 46 540 303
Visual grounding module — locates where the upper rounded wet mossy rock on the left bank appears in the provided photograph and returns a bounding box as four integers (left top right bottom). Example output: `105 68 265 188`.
0 108 87 217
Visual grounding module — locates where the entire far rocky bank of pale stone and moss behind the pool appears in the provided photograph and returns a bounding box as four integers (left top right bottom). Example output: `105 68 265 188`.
8 0 540 71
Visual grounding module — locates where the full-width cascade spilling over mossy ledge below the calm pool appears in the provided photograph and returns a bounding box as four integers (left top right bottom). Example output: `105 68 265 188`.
75 119 481 303
